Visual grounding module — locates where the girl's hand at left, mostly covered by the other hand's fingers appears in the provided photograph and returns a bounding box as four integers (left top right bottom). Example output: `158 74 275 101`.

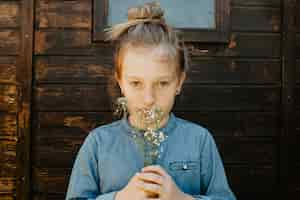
115 173 148 200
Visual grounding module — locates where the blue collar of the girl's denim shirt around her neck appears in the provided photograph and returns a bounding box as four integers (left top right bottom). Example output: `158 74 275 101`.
121 112 176 135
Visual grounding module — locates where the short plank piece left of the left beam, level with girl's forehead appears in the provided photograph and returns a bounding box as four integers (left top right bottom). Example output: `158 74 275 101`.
0 56 17 84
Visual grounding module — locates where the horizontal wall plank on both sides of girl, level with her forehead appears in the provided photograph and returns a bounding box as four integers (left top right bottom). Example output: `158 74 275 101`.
35 55 281 84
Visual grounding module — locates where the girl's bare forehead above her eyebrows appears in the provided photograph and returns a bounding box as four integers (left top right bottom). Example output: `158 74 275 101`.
122 46 177 78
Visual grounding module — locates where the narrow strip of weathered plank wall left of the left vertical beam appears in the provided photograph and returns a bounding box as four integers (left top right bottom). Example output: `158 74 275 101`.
0 1 21 200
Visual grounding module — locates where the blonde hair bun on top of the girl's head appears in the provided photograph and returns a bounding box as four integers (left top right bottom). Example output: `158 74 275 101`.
128 2 164 20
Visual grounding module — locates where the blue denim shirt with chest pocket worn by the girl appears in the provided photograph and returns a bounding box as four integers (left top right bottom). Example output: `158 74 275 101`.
66 113 236 200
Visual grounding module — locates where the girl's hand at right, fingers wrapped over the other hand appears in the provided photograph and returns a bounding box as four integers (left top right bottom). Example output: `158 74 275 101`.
137 165 192 200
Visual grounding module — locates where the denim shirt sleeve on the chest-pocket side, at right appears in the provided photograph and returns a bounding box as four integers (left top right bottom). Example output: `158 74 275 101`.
195 129 236 200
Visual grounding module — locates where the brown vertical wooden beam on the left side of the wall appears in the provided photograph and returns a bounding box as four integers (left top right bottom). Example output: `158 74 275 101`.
16 0 34 200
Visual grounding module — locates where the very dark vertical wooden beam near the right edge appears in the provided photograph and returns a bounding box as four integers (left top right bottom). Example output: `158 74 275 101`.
278 0 298 200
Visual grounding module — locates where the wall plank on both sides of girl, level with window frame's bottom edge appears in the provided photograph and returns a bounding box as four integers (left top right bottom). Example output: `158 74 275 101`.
35 29 280 58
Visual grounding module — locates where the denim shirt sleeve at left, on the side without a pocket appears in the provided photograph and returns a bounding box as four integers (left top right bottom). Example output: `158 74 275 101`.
66 132 116 200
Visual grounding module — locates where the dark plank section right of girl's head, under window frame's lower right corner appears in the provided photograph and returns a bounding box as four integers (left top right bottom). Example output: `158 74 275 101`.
186 32 280 59
